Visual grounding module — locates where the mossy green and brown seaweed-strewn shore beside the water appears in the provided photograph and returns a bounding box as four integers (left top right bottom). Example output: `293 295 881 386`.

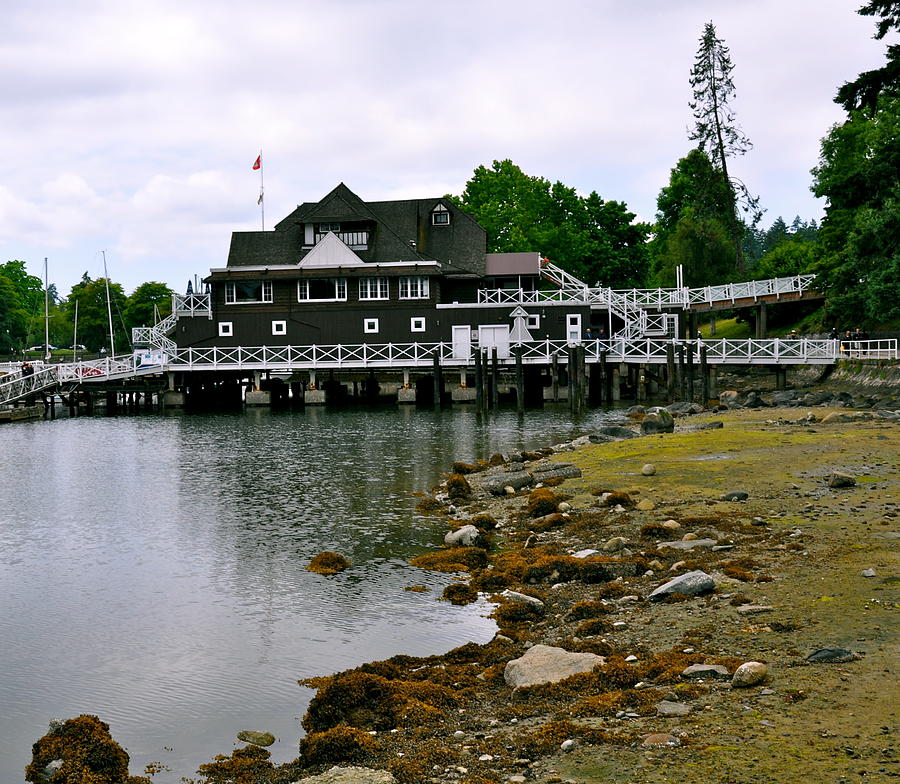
29 408 900 784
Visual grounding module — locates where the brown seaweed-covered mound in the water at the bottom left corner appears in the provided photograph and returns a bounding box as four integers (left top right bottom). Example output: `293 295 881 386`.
25 714 150 784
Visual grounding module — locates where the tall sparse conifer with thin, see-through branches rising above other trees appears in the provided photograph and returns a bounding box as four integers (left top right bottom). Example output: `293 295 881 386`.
688 22 761 270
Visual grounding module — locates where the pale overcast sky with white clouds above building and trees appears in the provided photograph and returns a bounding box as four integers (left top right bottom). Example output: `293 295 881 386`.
0 0 885 295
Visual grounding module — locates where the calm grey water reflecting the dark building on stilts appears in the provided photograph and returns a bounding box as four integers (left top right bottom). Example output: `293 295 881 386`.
0 408 624 784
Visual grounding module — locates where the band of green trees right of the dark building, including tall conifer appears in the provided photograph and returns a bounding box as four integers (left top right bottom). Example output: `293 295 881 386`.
451 0 900 328
